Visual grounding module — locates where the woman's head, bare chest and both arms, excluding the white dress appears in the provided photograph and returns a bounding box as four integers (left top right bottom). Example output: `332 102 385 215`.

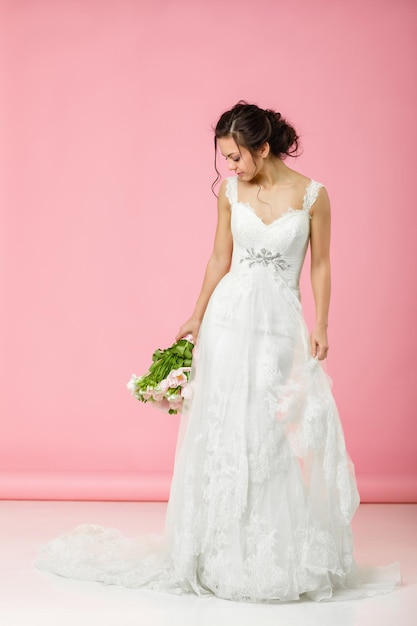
177 103 330 360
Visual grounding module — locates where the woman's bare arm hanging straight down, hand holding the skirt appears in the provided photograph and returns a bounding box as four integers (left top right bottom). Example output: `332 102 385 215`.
310 188 330 360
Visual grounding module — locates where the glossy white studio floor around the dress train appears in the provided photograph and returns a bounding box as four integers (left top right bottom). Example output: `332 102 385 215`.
0 501 417 626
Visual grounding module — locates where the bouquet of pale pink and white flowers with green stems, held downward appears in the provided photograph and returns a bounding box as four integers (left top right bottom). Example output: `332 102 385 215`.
127 335 194 415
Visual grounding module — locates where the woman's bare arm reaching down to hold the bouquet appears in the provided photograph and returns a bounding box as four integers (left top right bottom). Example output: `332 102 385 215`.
176 180 233 341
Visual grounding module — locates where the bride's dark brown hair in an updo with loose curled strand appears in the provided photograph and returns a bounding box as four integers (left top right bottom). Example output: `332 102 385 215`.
212 100 299 189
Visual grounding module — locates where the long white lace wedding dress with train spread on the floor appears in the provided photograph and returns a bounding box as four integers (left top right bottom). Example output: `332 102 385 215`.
37 177 400 602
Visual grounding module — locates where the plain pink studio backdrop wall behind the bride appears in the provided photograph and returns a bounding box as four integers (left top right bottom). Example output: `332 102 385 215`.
0 0 417 501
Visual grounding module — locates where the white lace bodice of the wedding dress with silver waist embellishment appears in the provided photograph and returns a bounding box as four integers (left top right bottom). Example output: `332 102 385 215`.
226 176 322 290
